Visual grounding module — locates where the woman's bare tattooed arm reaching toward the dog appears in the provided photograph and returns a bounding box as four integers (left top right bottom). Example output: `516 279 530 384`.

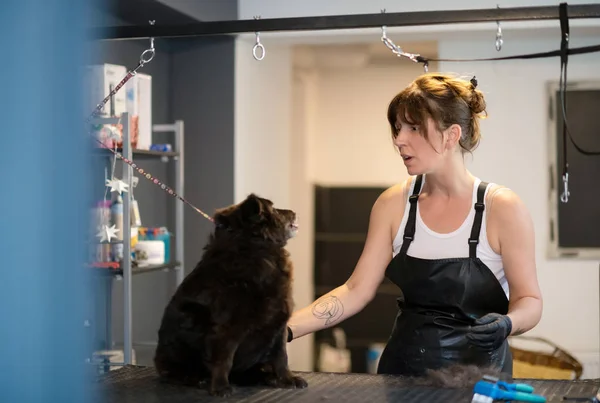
288 188 402 339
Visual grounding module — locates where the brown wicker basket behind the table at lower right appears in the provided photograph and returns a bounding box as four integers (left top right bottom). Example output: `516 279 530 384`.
511 336 583 380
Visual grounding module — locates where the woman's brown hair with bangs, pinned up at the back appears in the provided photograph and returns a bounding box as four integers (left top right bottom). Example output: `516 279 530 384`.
387 73 487 152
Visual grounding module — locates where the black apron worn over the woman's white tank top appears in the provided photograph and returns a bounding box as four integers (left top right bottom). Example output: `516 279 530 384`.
377 175 512 377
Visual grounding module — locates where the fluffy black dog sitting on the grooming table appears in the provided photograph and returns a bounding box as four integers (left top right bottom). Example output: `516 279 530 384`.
154 194 307 396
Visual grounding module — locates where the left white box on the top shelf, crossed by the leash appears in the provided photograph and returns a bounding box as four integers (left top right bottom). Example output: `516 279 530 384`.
85 63 127 117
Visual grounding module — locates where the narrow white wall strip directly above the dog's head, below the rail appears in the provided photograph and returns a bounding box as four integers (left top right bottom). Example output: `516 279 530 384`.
234 39 292 205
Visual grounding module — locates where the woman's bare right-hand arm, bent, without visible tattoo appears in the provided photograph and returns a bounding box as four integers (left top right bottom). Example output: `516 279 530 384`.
490 188 542 336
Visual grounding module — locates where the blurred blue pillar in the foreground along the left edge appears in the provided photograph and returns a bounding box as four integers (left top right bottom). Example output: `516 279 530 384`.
0 0 102 403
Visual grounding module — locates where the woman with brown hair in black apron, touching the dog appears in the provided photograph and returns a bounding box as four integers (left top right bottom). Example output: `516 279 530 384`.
288 73 542 376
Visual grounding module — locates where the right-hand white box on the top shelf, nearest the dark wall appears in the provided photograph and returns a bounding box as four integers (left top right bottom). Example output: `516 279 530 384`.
126 73 152 150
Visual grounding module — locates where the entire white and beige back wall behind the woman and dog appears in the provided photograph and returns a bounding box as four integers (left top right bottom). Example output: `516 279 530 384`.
235 0 600 377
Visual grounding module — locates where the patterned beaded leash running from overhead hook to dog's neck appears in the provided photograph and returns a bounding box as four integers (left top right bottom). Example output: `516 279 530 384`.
86 32 214 226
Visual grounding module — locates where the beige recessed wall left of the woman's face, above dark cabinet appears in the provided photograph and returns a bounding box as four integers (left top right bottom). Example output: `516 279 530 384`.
311 64 438 186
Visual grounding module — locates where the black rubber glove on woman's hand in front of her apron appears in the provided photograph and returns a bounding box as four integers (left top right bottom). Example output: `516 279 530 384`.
467 313 512 351
